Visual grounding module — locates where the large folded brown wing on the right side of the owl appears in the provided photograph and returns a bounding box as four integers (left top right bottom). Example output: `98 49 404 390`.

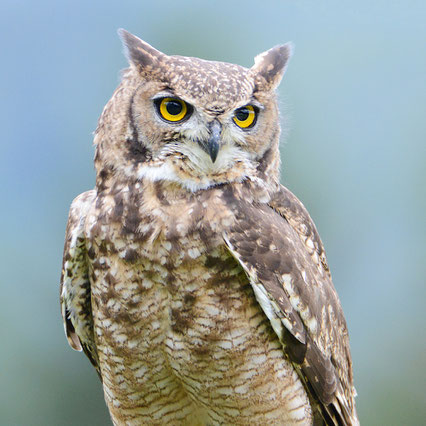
224 187 358 425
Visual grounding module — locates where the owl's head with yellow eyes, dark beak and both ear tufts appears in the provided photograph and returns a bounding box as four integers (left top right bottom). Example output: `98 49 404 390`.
95 30 291 192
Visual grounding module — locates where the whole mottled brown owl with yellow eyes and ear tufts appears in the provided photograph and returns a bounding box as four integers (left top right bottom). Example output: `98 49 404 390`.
61 30 358 425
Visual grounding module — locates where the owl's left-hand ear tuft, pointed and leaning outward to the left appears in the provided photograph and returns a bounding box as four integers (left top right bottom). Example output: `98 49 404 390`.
118 28 166 70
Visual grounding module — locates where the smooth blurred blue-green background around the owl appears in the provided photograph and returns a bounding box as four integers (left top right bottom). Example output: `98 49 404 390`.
0 0 426 426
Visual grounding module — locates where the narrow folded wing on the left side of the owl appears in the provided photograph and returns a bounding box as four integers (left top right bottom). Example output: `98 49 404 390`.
60 190 100 376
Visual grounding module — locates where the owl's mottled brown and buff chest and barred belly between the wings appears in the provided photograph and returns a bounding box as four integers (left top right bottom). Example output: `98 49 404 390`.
88 192 310 424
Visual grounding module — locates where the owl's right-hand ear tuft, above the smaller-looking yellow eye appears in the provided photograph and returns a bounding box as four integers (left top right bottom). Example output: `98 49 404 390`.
251 43 293 91
